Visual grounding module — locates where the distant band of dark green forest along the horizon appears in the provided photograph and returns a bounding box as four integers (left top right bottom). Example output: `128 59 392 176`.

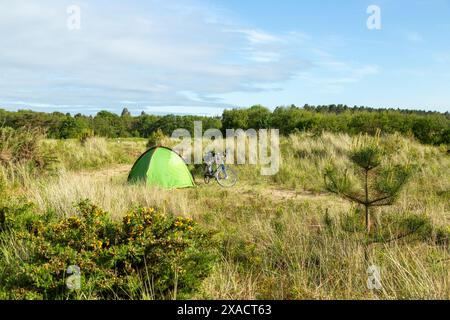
0 105 450 145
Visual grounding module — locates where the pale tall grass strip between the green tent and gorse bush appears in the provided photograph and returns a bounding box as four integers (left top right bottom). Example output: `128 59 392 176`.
27 171 193 218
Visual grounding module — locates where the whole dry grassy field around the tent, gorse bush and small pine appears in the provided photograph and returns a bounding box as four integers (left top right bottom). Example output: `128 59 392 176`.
0 133 450 299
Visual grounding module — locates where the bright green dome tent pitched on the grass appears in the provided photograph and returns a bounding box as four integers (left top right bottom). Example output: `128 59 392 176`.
128 147 195 189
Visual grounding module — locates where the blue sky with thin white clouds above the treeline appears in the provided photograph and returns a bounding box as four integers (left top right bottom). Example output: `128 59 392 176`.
0 0 450 115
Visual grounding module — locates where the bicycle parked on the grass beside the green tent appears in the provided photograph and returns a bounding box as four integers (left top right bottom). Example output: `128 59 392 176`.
203 152 237 188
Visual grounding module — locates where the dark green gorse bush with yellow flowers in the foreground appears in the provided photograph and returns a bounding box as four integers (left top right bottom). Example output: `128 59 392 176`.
0 200 214 299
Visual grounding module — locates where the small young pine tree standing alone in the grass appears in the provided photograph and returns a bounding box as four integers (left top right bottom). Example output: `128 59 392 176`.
324 134 412 232
